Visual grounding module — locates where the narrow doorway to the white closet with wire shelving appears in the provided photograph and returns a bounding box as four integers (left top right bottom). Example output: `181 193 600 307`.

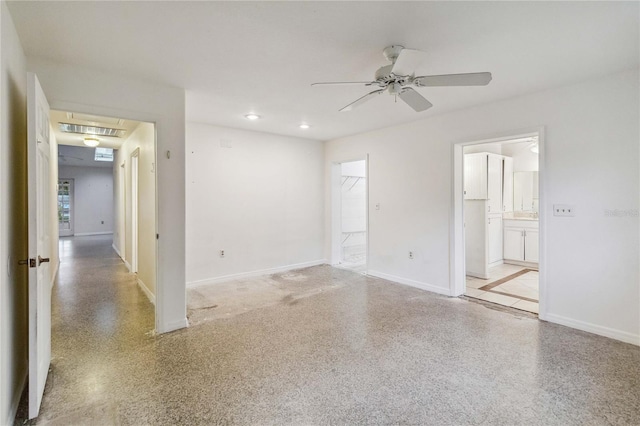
332 160 368 274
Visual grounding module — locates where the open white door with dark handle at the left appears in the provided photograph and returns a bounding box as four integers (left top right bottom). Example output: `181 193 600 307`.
27 73 53 418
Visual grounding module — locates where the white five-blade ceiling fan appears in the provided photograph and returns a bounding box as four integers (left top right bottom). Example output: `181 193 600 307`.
312 45 491 112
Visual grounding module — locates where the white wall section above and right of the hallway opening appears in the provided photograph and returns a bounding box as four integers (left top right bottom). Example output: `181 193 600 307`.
27 58 187 333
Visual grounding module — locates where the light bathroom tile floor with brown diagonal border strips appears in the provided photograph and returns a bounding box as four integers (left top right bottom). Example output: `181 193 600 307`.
465 263 539 314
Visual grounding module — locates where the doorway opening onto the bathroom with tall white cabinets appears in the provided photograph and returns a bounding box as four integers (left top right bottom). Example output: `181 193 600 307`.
456 132 543 314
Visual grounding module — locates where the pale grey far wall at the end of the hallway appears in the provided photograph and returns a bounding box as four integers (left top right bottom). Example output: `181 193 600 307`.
58 166 113 235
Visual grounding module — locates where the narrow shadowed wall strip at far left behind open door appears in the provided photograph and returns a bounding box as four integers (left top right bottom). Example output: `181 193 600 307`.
0 2 29 425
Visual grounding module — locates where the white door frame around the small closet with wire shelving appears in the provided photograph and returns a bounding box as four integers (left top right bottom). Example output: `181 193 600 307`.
331 154 370 274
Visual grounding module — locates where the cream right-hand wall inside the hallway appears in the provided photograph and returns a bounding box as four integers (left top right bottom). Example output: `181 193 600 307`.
113 123 156 302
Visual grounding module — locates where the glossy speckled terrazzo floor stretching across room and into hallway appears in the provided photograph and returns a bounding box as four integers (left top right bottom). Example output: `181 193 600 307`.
16 238 640 425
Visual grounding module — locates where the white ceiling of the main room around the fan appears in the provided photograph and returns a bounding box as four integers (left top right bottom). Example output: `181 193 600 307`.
8 1 640 140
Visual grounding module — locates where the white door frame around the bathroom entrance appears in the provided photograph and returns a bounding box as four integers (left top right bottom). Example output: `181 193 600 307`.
449 127 548 320
